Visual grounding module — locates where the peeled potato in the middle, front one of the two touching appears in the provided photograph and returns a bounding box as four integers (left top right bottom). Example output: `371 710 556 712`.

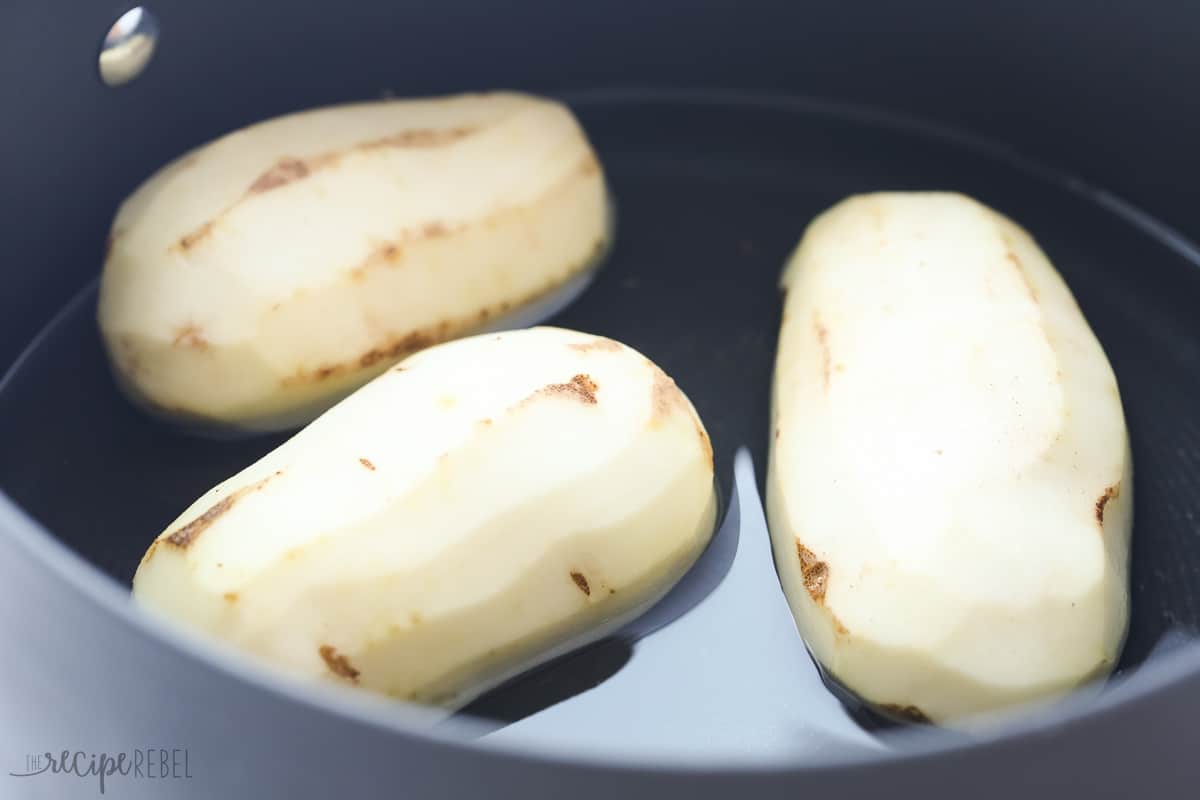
133 327 715 706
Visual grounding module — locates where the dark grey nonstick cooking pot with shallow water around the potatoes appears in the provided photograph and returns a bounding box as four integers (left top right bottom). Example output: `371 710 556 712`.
0 0 1200 800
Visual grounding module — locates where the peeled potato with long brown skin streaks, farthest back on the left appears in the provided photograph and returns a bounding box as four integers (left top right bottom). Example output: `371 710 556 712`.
100 94 608 431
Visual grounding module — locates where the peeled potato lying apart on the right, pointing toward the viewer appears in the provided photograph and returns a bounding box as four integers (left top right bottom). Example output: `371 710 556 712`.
768 193 1133 723
